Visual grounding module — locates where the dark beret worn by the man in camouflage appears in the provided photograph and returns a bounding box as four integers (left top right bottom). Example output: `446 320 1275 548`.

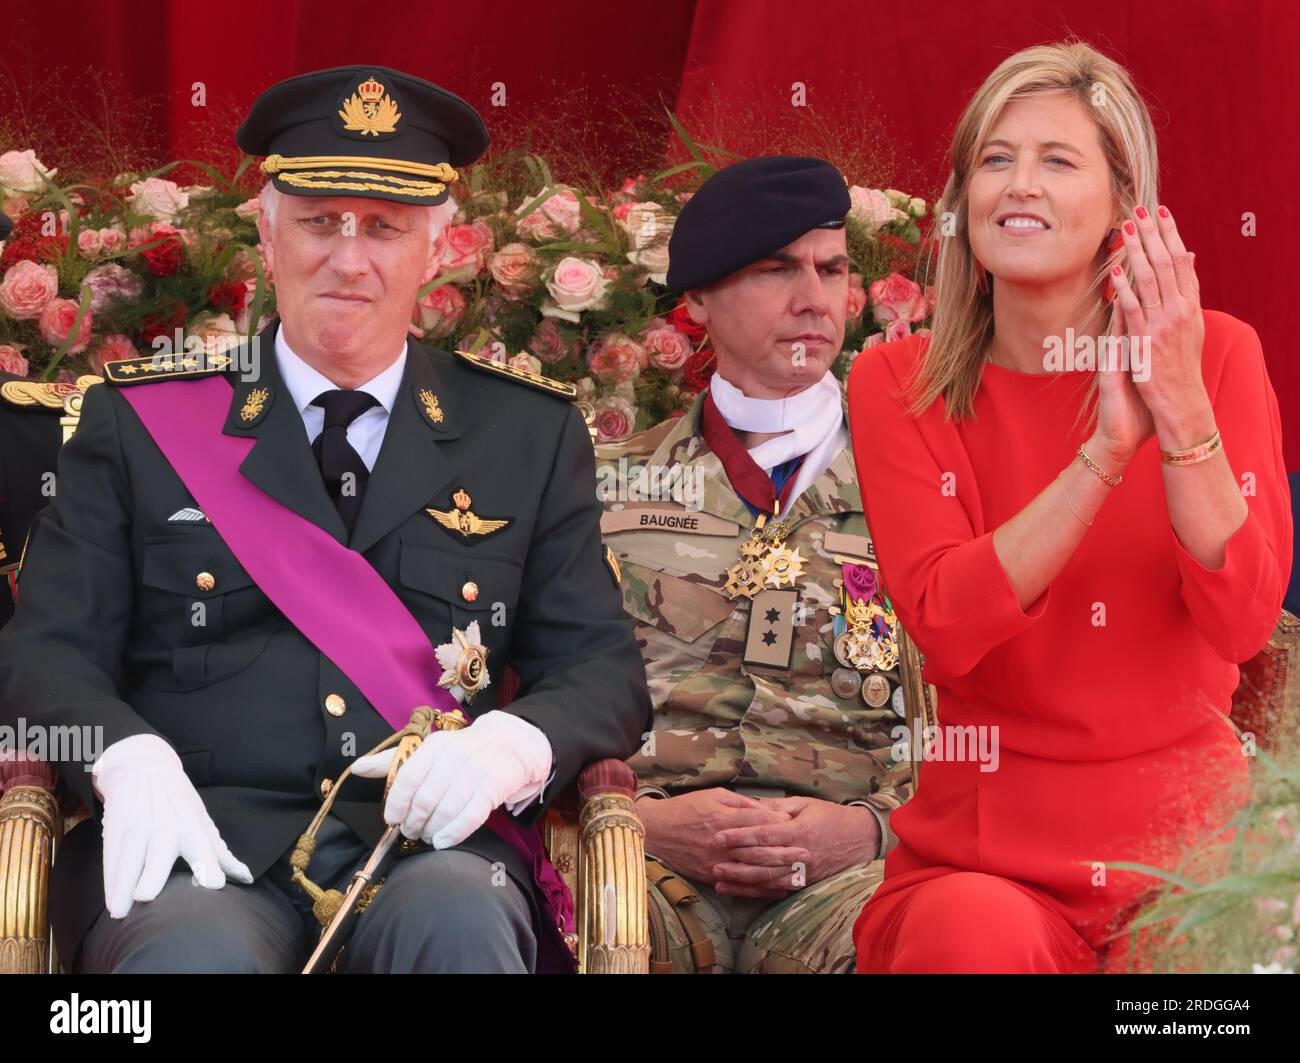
667 155 849 291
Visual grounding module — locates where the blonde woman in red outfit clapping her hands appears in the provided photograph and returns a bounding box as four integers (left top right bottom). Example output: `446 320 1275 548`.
849 43 1292 972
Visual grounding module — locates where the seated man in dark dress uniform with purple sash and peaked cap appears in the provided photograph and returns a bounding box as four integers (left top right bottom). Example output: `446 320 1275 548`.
0 66 650 972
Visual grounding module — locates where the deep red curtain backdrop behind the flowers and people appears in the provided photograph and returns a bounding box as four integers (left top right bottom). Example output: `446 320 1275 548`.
0 0 1300 470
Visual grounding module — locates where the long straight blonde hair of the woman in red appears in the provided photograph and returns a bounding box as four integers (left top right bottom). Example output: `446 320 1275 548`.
906 40 1158 420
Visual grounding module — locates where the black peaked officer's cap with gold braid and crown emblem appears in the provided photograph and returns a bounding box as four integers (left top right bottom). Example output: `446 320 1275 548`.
235 66 488 207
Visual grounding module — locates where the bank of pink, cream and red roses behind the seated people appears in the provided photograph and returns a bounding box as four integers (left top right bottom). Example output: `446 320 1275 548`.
0 135 932 442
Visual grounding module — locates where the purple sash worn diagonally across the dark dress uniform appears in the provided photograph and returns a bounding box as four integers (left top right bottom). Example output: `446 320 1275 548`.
121 377 573 973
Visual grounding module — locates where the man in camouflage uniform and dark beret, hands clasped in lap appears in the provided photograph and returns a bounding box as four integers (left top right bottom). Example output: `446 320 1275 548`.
597 157 910 972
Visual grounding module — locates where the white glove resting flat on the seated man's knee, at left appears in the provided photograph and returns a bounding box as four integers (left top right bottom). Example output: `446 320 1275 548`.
91 734 252 919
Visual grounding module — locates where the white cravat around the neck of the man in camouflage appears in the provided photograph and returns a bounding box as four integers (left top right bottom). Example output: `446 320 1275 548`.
709 369 849 512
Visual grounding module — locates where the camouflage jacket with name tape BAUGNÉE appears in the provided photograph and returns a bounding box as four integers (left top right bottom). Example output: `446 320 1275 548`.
597 396 911 855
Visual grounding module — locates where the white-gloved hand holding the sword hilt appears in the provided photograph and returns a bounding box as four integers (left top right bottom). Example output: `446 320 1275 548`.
352 710 551 849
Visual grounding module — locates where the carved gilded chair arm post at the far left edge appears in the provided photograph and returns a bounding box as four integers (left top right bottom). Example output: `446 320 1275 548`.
0 759 59 975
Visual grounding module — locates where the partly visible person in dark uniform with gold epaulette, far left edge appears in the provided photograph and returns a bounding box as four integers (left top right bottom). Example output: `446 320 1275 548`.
0 214 73 628
